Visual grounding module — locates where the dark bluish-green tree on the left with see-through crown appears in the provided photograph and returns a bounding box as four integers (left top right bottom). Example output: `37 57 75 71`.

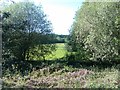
2 2 55 60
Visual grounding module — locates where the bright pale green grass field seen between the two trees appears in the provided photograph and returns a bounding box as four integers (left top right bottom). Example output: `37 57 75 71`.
45 43 67 60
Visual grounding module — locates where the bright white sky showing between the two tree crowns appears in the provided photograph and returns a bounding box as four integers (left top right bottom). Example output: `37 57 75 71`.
0 0 84 35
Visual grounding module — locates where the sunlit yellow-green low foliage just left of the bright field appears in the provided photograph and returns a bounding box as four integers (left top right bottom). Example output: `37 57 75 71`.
29 44 56 60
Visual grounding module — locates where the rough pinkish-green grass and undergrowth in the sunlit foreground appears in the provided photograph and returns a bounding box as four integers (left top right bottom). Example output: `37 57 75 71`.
3 64 120 88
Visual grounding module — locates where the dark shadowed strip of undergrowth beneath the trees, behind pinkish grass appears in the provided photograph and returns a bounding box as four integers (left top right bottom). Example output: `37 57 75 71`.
2 58 120 76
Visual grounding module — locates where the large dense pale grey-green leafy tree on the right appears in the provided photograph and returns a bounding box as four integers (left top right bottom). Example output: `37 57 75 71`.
69 2 120 61
